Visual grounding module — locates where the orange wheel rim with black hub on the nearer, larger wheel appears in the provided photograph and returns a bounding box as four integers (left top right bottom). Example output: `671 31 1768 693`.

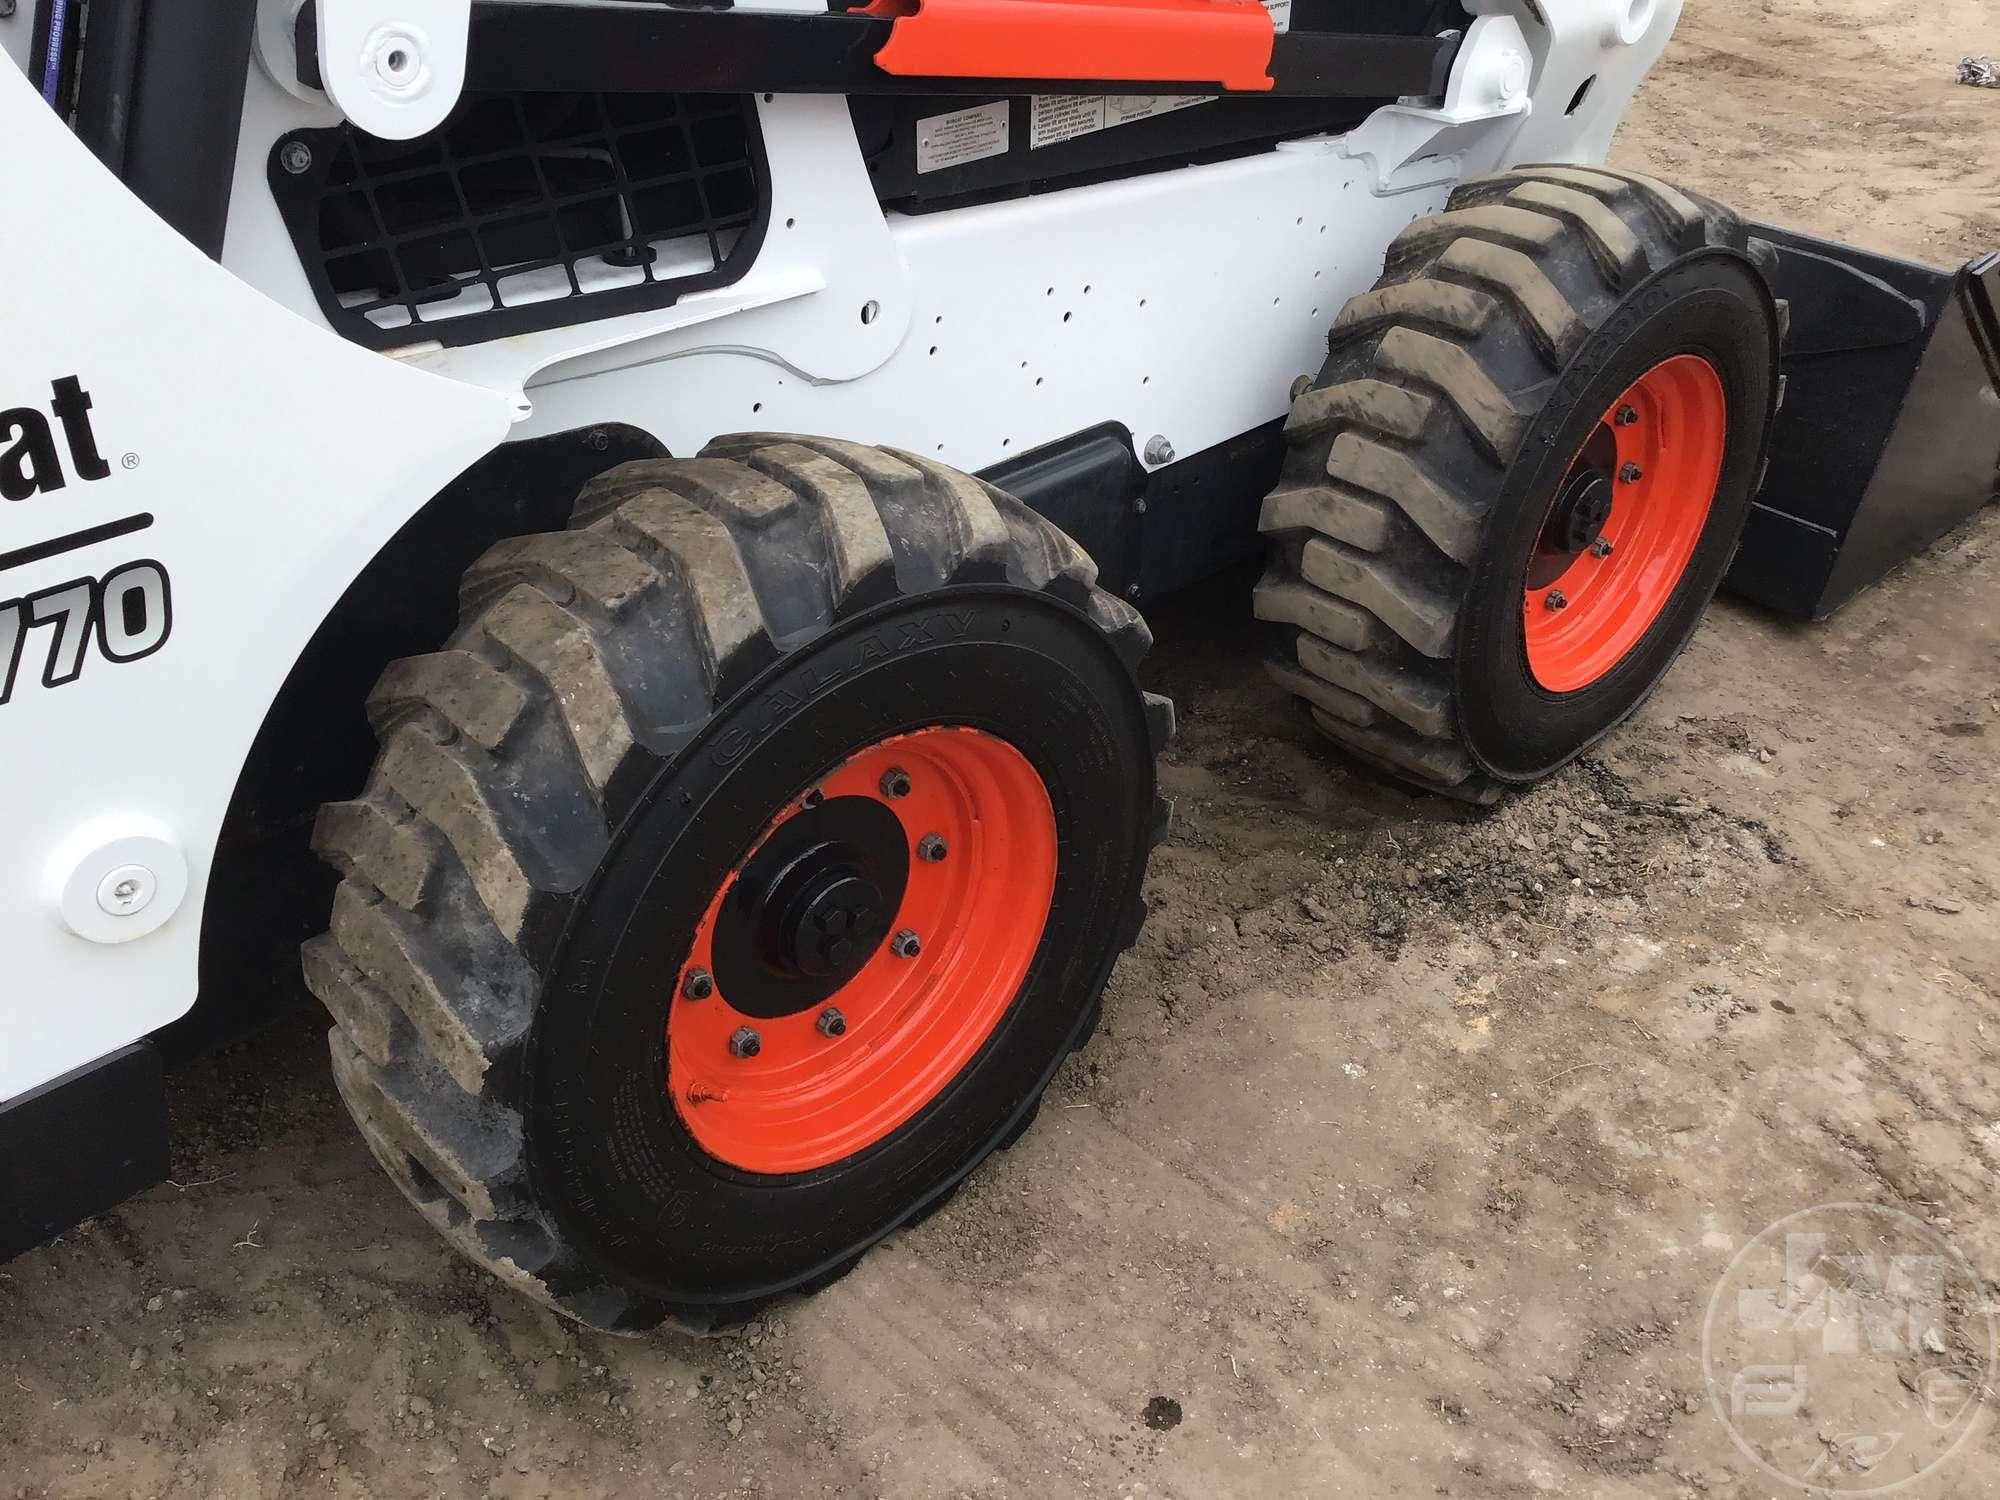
666 726 1056 1174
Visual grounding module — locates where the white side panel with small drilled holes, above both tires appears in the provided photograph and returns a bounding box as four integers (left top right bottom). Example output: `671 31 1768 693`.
215 0 1680 488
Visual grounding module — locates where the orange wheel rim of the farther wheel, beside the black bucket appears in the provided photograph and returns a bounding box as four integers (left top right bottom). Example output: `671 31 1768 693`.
1522 354 1728 692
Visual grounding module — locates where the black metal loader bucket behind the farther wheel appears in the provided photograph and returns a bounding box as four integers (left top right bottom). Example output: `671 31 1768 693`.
1728 226 2000 620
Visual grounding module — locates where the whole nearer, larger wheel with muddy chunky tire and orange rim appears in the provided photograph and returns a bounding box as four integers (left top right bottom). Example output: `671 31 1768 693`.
304 436 1172 1332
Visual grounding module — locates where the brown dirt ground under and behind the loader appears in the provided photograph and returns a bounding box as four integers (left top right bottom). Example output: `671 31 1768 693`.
0 0 2000 1500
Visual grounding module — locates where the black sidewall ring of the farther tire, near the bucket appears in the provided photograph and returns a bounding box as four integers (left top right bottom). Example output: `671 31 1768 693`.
1454 250 1778 784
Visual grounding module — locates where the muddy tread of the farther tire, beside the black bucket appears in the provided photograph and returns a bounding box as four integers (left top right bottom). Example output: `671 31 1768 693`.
1254 166 1784 804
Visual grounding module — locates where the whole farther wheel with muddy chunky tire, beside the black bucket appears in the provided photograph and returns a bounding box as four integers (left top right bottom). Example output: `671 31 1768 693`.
1256 166 1784 804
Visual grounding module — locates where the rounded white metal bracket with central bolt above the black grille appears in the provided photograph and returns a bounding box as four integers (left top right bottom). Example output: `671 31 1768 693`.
318 0 472 140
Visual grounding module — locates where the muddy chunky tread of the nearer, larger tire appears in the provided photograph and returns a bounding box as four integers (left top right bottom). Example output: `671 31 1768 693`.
302 434 1174 1332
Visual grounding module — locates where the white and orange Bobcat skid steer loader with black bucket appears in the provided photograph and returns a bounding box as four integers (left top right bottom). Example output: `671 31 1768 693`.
0 0 2000 1328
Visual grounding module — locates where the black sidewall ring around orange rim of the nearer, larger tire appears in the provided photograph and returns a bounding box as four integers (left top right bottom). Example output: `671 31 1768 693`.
526 588 1154 1306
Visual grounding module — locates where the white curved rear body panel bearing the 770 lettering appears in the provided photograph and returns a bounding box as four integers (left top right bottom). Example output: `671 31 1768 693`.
0 68 512 1098
